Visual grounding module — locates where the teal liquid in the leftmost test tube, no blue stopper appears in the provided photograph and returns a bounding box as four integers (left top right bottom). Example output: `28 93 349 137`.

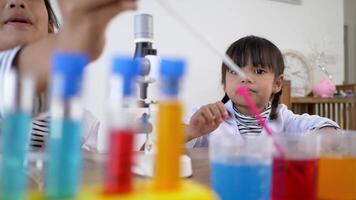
0 113 31 200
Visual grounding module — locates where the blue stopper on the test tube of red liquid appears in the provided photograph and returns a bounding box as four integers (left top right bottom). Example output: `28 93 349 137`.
112 57 139 97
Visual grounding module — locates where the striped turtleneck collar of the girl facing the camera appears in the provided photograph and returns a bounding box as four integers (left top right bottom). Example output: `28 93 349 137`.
233 103 271 136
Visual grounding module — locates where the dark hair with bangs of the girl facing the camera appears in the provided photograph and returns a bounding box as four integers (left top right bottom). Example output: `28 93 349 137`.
221 36 284 120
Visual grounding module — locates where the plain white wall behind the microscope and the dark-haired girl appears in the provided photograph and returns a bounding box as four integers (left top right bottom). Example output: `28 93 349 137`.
51 0 344 151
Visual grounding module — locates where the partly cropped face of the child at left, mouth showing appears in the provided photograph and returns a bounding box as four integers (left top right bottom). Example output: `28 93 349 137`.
0 0 49 50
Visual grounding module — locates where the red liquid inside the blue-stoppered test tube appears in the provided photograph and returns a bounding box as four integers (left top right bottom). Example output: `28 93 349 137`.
105 130 134 194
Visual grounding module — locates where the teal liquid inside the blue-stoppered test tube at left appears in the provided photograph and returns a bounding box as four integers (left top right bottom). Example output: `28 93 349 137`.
45 119 82 198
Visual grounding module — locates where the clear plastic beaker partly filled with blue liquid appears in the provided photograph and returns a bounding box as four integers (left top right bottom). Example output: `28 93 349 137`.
209 134 273 200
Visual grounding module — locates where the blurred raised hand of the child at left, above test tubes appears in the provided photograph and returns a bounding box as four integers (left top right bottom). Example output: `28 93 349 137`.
59 0 137 59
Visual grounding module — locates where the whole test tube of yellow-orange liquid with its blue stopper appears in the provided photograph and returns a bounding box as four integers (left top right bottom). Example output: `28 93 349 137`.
153 60 184 191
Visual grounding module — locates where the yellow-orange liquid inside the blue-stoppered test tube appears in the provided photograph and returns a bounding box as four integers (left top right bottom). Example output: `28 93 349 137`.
154 101 183 190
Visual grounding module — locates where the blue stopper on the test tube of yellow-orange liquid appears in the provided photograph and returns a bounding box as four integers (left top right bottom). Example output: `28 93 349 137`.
160 59 185 96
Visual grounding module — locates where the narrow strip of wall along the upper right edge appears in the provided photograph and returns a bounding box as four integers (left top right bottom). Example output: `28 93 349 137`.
344 0 356 83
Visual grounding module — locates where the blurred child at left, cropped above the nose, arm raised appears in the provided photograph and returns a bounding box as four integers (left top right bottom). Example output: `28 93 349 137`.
0 0 137 150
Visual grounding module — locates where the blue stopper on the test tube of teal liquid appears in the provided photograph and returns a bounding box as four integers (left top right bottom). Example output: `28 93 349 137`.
52 52 89 99
